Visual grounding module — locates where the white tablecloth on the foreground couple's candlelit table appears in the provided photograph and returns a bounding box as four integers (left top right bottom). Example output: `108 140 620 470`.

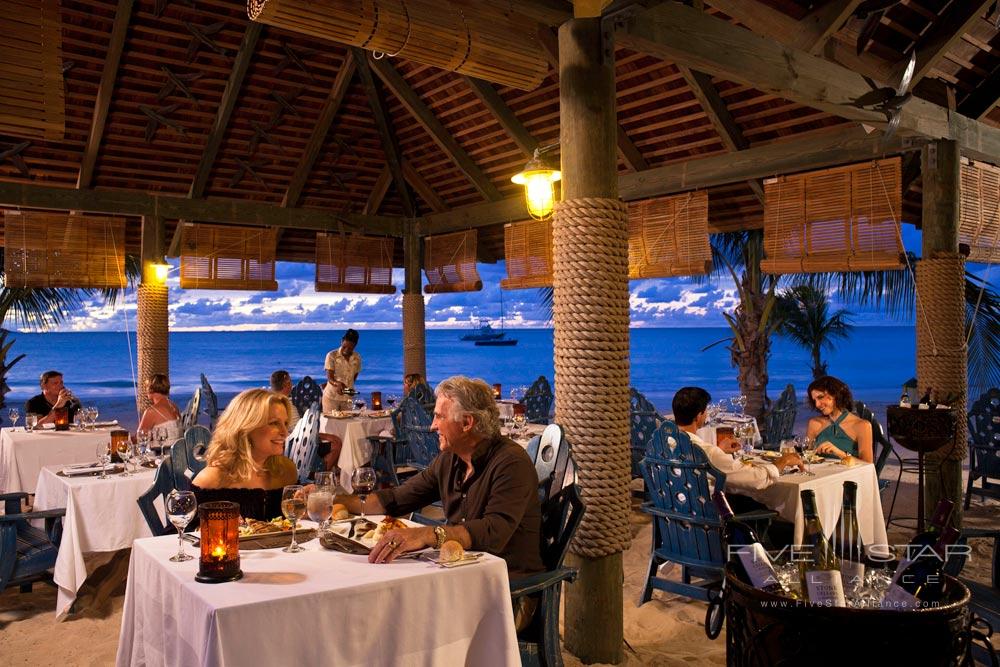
117 536 521 667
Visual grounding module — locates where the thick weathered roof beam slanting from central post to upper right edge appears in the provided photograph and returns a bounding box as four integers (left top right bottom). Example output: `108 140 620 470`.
618 3 1000 162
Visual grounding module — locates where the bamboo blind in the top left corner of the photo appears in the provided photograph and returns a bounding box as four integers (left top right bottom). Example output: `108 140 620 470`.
0 0 66 141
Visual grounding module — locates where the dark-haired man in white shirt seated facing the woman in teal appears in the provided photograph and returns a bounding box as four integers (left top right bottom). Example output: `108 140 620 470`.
672 387 802 514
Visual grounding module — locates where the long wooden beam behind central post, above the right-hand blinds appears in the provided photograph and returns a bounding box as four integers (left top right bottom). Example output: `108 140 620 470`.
420 127 923 235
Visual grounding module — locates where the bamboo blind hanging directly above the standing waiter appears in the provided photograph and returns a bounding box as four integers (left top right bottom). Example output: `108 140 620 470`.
316 232 396 294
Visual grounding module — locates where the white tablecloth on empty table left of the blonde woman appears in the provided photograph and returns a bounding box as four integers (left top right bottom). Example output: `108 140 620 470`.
35 465 163 619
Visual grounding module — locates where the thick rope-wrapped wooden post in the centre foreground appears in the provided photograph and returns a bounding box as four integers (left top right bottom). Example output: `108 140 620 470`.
553 18 630 664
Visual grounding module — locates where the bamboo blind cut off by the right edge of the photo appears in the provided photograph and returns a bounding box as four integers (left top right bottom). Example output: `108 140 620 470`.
958 162 1000 264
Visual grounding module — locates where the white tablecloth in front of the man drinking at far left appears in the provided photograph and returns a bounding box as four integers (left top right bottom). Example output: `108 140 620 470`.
0 427 117 493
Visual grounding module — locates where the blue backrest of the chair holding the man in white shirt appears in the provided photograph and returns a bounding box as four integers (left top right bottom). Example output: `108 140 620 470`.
642 421 726 568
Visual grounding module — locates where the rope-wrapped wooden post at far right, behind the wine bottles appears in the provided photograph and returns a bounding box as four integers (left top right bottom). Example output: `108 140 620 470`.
916 140 968 528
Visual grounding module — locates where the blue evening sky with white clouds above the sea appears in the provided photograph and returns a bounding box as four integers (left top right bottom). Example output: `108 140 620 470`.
33 225 997 331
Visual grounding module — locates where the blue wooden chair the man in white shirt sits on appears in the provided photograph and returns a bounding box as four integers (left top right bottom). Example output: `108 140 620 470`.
639 421 777 605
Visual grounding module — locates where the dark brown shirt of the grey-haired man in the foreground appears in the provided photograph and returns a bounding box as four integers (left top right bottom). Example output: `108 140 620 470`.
376 435 545 578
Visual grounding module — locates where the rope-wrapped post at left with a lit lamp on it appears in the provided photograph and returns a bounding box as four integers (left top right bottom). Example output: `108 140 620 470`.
136 215 170 414
